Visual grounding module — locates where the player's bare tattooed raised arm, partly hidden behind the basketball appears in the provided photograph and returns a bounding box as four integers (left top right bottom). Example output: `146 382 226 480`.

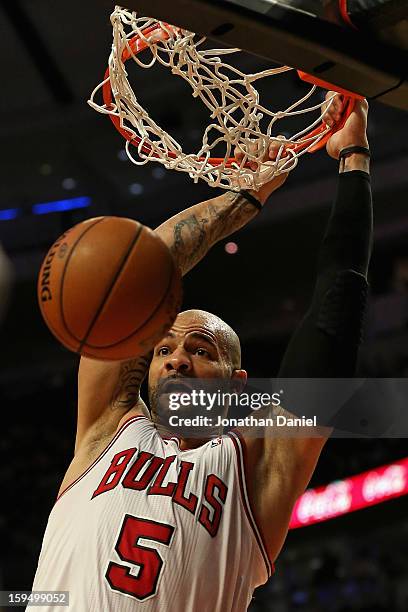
76 175 287 450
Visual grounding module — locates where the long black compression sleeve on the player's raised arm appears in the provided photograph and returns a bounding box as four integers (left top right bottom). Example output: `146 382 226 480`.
278 170 373 378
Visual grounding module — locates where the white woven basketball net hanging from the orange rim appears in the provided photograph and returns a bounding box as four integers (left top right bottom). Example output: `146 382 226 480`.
89 7 338 190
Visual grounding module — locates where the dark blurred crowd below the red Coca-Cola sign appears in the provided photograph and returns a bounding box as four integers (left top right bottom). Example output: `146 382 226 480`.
249 507 408 612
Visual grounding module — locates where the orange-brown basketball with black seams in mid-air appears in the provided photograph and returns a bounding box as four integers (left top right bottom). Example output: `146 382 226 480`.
37 217 182 360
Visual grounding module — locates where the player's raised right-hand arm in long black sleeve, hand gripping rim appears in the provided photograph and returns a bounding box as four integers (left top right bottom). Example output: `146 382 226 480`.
242 99 372 560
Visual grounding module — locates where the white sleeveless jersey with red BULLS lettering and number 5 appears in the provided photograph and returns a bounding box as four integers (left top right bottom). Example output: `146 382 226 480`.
33 416 272 612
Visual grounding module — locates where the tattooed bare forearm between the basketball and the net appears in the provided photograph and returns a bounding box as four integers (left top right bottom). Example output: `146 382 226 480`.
167 192 258 274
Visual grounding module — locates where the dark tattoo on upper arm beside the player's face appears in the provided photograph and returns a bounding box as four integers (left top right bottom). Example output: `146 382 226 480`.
111 354 151 410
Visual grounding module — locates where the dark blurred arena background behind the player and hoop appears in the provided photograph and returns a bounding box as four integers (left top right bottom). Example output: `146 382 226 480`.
0 0 408 612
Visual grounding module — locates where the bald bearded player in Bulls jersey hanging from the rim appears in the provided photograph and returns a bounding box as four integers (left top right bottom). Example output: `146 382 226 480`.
30 96 372 612
